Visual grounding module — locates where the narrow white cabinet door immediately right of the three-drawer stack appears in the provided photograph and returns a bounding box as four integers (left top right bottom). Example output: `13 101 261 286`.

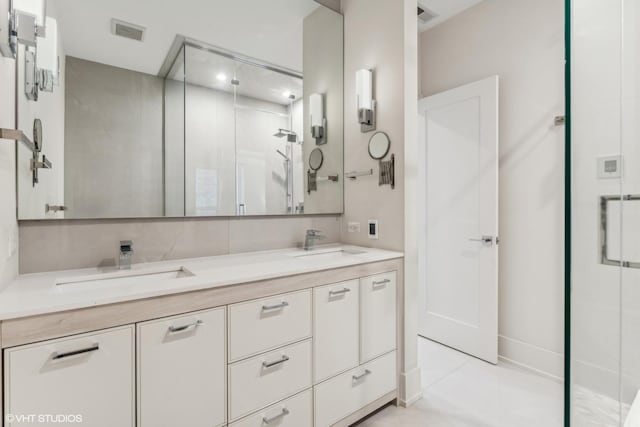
313 280 360 383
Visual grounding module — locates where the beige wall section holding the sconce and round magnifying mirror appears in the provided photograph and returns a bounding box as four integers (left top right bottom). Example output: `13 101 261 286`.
342 0 421 405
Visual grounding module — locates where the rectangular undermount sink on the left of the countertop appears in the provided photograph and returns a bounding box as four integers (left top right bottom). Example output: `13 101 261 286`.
56 267 195 286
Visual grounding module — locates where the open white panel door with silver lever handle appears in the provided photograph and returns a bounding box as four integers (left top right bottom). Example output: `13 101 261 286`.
419 76 499 363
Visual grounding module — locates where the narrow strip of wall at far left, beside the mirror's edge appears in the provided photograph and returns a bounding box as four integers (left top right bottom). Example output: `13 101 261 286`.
0 56 18 289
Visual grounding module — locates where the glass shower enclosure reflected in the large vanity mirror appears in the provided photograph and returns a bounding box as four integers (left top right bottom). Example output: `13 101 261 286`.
184 45 304 216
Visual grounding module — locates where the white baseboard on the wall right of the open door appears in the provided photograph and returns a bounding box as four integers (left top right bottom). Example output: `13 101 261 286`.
498 335 564 381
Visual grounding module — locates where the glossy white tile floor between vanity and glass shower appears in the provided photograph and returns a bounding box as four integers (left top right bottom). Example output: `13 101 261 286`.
358 338 563 427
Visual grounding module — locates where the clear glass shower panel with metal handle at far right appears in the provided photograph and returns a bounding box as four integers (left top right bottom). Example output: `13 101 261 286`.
567 0 640 427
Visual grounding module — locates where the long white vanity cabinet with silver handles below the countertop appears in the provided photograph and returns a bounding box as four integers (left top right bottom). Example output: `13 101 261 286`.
0 260 402 427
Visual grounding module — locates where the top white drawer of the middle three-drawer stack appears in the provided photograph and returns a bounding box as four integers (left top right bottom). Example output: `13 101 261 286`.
229 290 311 361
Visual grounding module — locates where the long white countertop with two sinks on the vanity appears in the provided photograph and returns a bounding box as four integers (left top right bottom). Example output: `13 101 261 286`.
0 245 403 320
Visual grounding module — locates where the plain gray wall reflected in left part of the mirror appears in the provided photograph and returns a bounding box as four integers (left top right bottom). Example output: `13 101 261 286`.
64 57 164 218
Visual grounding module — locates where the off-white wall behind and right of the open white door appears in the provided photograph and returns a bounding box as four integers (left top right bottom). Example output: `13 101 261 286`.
420 0 564 377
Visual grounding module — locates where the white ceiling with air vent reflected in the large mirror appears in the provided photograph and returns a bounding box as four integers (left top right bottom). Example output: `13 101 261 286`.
48 0 322 75
